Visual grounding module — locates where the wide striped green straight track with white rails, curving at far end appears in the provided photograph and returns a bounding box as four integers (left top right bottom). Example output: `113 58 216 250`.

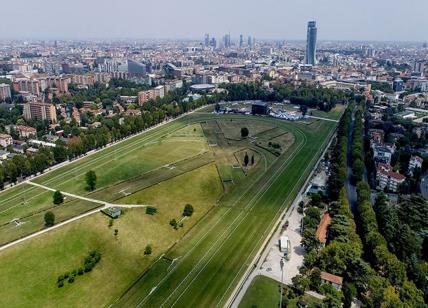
117 114 335 307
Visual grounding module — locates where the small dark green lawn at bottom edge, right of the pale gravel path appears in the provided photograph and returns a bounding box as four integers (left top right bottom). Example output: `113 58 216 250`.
239 276 281 308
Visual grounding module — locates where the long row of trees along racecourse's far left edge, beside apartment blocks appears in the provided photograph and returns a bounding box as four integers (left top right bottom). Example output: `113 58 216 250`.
0 84 217 188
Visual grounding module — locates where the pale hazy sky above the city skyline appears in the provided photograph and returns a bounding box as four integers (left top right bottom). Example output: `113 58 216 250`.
0 0 428 41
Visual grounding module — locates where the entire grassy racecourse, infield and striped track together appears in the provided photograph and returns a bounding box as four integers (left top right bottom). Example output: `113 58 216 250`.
0 109 335 307
